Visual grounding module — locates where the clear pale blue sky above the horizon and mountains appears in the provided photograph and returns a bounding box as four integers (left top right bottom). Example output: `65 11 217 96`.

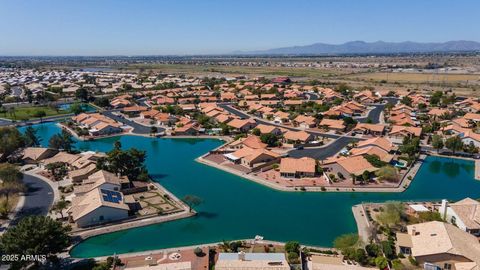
0 0 480 55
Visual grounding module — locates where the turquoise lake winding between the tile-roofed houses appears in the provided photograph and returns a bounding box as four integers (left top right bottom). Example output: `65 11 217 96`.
16 123 480 257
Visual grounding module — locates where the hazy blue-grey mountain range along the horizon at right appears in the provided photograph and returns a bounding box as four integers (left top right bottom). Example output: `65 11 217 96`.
234 40 480 55
